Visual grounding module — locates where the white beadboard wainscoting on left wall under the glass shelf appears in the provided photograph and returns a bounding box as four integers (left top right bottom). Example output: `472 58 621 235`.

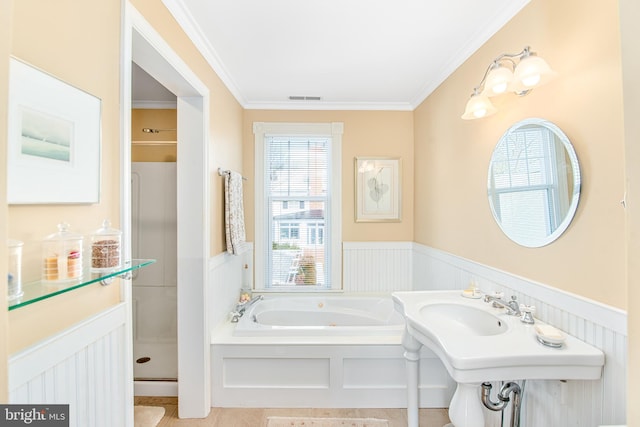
8 304 133 427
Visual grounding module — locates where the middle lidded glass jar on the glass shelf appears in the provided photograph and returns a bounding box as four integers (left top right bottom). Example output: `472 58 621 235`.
42 223 83 283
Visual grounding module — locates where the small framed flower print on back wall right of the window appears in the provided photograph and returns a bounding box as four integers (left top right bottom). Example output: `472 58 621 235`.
355 157 402 222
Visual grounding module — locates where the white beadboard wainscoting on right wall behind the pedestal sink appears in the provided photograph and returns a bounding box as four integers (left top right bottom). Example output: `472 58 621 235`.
413 244 627 427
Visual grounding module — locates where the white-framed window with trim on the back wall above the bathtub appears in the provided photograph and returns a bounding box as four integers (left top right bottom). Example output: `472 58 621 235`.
254 123 342 291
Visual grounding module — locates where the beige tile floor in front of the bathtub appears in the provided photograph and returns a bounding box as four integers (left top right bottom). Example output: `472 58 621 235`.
134 396 449 427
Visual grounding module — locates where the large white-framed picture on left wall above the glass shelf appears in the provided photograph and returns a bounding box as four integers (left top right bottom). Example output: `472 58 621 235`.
7 58 101 204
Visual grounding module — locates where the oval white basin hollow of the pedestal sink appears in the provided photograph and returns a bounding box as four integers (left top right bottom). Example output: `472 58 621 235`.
420 303 508 336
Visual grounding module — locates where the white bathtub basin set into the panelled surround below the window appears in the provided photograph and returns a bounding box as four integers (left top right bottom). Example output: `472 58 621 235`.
234 296 404 336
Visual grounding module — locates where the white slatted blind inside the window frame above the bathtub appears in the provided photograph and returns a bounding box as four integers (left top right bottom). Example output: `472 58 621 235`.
264 136 331 288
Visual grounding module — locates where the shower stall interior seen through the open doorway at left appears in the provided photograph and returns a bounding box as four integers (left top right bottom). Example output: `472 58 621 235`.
131 62 178 386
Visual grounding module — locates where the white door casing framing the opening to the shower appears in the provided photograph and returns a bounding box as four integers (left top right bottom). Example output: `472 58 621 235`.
121 3 211 418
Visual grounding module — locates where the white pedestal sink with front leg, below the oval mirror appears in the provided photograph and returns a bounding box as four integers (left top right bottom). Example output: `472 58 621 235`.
392 291 604 427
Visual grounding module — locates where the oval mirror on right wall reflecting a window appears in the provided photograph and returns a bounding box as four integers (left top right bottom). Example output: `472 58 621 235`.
487 118 580 248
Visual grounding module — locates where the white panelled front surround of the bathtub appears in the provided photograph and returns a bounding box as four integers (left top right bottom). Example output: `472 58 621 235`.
211 332 455 408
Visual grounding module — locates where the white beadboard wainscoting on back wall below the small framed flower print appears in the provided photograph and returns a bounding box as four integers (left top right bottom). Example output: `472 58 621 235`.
342 242 413 293
